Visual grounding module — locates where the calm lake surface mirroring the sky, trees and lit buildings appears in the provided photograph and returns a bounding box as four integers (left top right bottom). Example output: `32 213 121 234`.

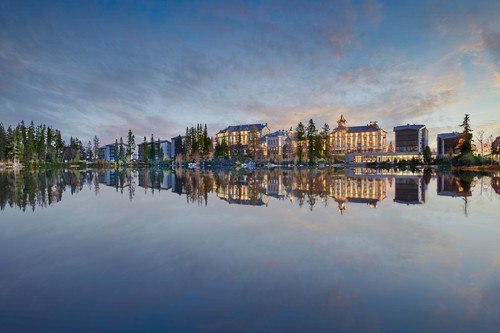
0 169 500 332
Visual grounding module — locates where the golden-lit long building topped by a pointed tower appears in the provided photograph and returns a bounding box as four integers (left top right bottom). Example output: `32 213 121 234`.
329 115 387 154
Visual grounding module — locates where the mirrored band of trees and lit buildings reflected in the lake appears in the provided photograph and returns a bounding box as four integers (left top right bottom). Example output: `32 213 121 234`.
0 169 500 214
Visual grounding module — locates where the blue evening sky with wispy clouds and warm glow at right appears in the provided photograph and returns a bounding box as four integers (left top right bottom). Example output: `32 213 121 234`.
0 0 500 147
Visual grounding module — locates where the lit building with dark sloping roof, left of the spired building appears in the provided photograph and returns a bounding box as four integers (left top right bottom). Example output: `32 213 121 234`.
215 123 271 158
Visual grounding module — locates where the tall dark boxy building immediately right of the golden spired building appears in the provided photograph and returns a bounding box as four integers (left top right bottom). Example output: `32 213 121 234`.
394 124 429 154
